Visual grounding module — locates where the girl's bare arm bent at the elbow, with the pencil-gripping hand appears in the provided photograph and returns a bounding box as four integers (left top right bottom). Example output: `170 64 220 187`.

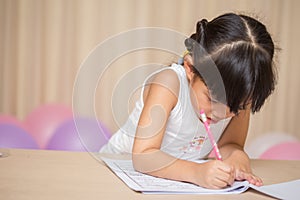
132 70 234 188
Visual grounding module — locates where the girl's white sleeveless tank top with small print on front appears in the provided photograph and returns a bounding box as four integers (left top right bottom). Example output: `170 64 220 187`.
100 64 231 160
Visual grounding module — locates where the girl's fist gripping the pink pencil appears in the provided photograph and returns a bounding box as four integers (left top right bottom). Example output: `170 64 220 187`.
194 160 235 189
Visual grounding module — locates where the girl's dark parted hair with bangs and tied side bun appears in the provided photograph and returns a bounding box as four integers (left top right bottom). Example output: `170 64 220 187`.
185 13 276 113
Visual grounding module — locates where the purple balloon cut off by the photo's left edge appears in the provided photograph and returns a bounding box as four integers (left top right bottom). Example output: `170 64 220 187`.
0 123 38 149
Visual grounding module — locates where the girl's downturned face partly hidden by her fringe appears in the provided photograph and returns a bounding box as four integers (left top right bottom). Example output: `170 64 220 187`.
190 76 235 123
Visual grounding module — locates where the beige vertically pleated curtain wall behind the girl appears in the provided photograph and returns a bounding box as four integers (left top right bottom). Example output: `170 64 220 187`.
0 0 300 155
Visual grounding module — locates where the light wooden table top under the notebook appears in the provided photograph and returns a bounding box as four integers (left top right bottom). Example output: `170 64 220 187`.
0 149 300 200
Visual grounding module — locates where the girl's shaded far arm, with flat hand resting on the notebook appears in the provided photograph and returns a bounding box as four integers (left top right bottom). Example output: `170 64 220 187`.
218 108 262 186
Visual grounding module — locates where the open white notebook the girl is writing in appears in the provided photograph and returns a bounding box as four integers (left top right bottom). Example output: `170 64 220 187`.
102 158 300 199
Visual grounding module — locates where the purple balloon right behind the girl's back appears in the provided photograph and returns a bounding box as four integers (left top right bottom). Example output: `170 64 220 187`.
47 117 111 152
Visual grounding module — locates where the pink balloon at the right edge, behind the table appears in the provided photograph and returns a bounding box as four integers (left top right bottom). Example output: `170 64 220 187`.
260 141 300 160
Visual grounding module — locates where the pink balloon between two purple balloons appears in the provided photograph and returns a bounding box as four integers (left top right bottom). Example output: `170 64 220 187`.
24 104 73 149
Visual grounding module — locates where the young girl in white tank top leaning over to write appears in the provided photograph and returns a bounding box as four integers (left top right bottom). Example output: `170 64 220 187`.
100 13 276 189
